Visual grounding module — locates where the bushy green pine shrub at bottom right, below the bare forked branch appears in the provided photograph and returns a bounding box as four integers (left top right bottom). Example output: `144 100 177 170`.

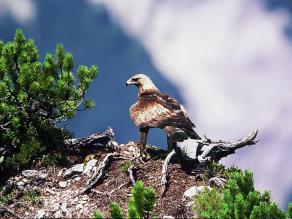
194 169 285 219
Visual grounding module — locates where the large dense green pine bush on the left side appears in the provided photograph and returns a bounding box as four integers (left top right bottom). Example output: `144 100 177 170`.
0 30 98 172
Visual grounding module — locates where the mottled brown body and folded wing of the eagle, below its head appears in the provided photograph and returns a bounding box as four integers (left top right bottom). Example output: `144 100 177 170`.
130 91 195 130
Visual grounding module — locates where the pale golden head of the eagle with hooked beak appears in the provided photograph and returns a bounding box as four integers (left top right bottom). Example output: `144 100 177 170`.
126 74 158 93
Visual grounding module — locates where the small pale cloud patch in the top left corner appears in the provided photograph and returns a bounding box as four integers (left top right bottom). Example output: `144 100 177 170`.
0 0 35 23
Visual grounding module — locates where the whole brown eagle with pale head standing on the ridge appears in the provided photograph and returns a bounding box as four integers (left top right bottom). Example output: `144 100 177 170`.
127 74 200 156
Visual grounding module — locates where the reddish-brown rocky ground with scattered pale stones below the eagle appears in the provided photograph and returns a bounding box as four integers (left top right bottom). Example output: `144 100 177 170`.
0 141 221 218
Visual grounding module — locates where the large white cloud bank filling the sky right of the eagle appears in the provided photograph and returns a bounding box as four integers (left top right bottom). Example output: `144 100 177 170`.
89 0 292 204
